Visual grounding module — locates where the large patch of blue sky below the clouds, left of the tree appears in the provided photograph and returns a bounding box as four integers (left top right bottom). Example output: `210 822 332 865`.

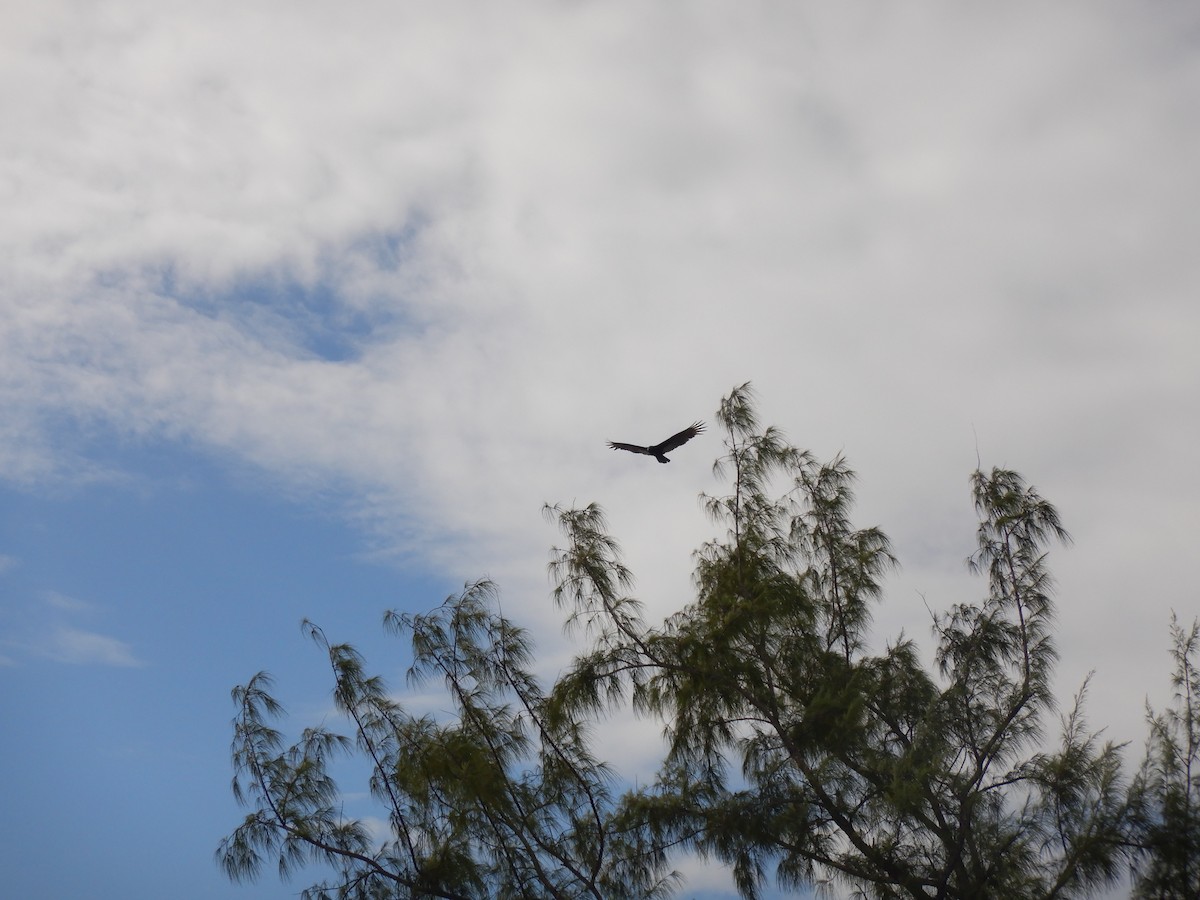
0 450 454 898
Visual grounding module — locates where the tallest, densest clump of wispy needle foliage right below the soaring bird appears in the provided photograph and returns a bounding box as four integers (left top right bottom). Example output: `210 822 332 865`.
556 386 1127 899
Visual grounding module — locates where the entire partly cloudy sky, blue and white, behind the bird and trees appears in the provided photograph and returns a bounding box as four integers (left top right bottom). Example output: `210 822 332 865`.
0 0 1200 900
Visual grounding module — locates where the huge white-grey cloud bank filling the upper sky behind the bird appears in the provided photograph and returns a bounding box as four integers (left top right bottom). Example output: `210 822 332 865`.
0 1 1200 787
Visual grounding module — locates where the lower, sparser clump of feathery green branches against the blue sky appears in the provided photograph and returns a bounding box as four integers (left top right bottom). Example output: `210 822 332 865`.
217 582 674 898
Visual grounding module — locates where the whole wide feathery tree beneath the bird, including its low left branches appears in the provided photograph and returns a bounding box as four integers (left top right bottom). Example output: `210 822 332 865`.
218 385 1132 899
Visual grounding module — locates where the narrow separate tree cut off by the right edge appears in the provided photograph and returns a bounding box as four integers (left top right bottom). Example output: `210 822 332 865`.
1133 617 1200 900
